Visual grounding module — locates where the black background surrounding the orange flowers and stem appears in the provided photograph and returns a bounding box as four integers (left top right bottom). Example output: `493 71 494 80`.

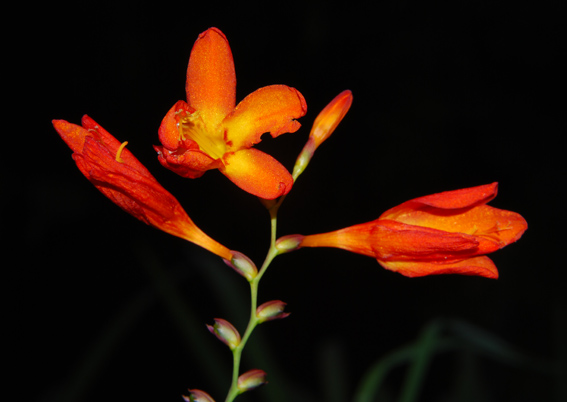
6 1 567 402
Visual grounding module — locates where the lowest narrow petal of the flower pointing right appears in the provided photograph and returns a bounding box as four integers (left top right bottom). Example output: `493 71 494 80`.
378 256 498 279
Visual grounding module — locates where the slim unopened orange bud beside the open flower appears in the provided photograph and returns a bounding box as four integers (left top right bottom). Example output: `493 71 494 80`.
292 89 352 180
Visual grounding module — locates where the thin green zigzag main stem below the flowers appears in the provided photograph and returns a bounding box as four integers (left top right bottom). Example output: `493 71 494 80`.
225 204 283 402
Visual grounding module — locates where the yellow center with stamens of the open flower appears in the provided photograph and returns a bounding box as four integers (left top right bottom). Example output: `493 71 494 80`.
179 112 226 159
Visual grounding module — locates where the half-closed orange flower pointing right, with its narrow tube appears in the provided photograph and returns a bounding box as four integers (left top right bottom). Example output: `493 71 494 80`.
298 183 528 278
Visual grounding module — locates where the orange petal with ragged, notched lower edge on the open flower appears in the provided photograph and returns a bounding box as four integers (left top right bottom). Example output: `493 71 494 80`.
223 85 307 151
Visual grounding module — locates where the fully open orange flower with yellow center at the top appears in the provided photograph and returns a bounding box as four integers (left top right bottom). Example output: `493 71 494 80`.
154 28 307 199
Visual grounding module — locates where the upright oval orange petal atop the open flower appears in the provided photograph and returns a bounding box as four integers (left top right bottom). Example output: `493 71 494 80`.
185 28 236 129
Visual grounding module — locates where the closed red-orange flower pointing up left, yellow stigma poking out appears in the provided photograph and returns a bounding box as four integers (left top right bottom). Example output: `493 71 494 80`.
53 115 233 261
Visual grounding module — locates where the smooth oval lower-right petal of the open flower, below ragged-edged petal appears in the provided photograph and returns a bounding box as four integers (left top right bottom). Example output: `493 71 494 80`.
219 148 293 200
